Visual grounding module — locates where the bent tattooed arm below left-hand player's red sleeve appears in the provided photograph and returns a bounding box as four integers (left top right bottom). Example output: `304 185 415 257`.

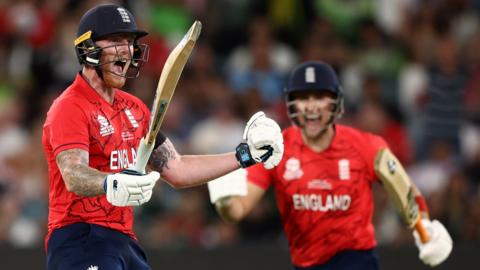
56 149 107 197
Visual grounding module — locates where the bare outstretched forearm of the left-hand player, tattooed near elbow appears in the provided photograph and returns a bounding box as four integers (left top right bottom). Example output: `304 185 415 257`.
148 139 240 188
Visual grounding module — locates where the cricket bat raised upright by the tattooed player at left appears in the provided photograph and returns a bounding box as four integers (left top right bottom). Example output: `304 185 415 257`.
134 21 202 173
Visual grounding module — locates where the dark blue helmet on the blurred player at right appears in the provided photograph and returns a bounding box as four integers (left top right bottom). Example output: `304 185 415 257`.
285 61 344 125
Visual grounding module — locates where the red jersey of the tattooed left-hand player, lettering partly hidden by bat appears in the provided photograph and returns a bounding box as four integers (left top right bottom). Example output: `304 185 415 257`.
42 74 150 247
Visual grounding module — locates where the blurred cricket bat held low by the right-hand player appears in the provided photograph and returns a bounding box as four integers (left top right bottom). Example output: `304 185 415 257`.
375 148 429 243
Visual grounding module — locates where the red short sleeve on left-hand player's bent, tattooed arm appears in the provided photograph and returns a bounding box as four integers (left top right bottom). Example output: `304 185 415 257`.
49 102 90 156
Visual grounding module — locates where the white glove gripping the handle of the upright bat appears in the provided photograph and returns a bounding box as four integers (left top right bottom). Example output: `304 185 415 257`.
104 170 160 206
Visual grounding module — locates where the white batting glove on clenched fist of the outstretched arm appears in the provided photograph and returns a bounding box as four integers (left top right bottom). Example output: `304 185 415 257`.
238 111 283 169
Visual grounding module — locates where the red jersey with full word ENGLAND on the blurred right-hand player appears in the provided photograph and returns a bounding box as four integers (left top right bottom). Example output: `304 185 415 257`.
248 125 386 267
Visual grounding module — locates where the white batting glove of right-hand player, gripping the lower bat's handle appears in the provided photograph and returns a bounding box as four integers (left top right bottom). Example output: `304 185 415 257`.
413 219 453 267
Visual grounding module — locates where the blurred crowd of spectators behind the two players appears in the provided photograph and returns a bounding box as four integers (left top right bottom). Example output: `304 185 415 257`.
0 0 480 248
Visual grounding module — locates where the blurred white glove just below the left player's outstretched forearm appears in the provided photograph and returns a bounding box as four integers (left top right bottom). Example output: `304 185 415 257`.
207 169 247 204
